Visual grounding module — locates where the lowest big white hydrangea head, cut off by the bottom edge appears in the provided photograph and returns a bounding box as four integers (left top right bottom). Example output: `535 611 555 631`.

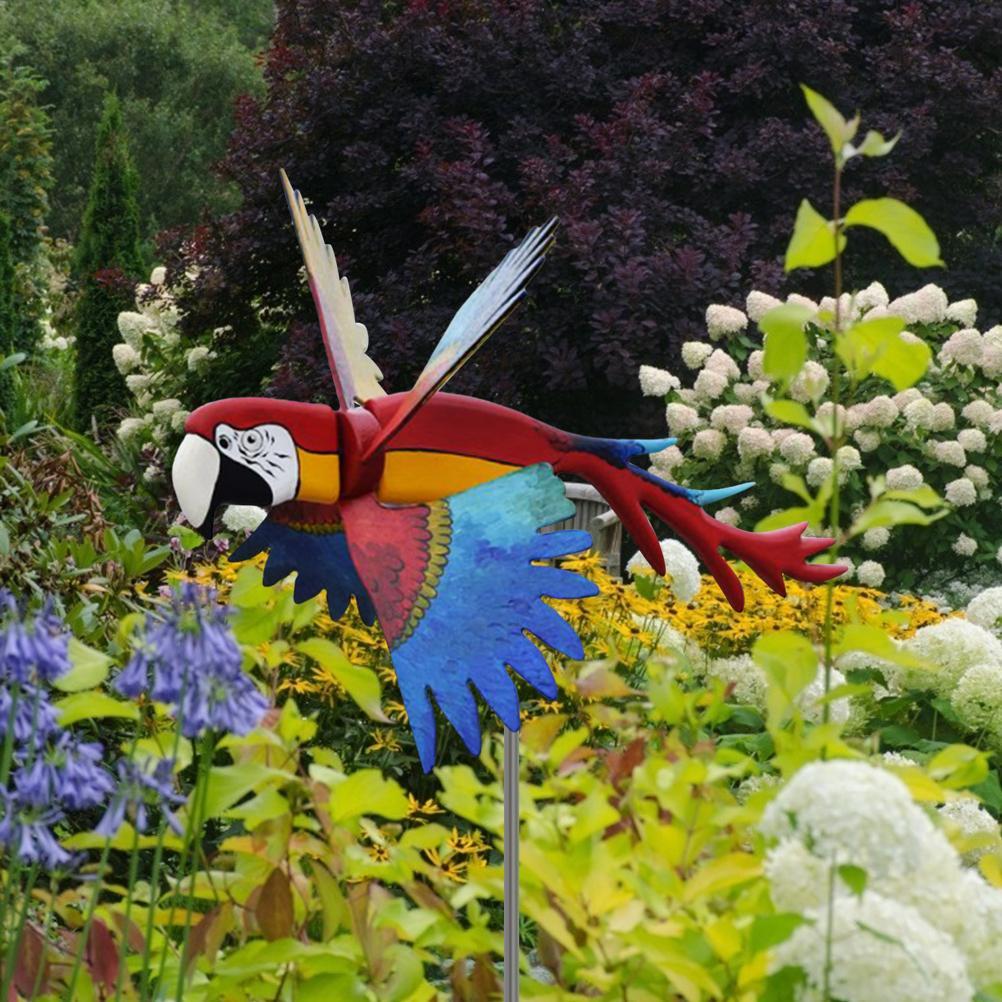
772 891 974 1002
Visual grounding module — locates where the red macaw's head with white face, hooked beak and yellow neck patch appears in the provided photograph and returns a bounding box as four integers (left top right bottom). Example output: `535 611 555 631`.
171 397 341 538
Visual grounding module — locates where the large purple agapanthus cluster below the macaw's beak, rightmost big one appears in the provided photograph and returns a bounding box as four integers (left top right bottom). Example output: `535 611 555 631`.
114 583 268 737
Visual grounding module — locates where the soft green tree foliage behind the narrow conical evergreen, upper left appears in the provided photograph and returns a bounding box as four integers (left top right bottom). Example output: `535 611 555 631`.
0 0 272 239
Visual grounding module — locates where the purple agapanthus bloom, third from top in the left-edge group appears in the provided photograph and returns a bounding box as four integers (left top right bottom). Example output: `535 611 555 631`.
18 730 115 811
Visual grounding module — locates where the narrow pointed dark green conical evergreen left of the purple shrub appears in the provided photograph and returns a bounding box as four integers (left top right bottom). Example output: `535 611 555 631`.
73 94 142 429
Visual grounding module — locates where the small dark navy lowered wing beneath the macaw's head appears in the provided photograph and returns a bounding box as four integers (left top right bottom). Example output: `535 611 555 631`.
229 501 376 623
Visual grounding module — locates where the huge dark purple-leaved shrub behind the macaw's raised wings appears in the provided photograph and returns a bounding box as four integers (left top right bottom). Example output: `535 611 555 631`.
174 0 1002 434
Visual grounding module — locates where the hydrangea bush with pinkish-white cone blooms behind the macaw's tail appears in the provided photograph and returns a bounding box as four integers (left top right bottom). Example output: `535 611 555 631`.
640 282 1002 590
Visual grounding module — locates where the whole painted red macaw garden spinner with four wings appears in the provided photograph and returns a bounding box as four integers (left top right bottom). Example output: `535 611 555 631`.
172 171 842 771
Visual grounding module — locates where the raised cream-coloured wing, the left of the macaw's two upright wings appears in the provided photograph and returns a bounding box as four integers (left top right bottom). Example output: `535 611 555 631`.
282 170 386 410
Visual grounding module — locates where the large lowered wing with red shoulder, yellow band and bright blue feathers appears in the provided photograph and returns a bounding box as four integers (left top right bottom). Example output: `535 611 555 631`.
342 464 597 772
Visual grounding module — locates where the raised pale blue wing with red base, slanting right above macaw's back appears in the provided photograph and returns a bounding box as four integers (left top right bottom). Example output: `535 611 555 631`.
363 218 557 459
